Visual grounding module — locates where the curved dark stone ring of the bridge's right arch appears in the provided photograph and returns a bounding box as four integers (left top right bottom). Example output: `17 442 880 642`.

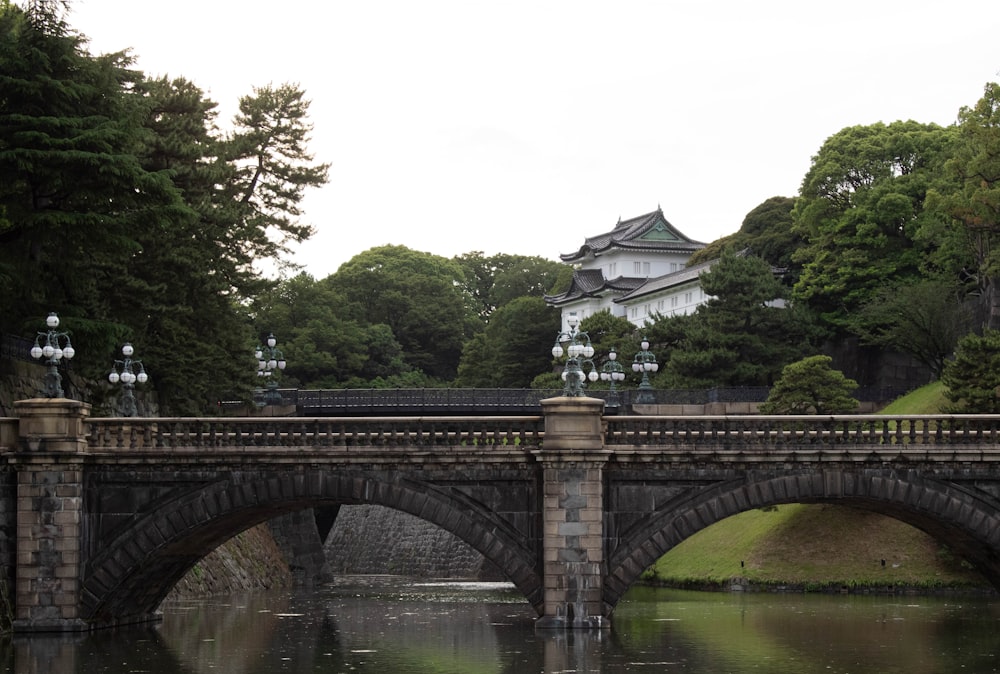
603 469 1000 616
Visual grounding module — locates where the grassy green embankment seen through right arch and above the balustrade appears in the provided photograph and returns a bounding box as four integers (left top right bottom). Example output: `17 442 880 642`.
644 383 991 592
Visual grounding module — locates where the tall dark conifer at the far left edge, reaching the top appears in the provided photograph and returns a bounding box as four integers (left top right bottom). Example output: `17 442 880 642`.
0 3 192 388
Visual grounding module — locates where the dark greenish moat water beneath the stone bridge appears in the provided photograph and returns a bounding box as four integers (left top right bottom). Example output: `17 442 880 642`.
0 577 1000 674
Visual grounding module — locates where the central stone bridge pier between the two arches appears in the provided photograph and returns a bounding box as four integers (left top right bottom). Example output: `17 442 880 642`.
533 397 611 630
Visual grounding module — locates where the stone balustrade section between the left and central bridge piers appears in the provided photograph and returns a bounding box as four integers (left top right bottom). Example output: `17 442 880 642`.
86 416 544 451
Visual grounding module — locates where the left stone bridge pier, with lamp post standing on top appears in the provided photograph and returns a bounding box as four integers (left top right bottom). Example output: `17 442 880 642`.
10 398 90 632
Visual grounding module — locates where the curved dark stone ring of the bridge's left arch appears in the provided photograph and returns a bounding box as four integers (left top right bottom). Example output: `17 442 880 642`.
81 470 543 625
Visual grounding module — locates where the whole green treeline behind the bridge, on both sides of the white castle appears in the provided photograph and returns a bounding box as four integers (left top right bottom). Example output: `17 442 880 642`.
0 0 1000 414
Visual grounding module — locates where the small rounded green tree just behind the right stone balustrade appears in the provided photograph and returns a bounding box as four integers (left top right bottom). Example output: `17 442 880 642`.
760 355 860 414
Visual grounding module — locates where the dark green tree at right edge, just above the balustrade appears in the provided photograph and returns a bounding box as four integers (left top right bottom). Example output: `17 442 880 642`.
941 328 1000 414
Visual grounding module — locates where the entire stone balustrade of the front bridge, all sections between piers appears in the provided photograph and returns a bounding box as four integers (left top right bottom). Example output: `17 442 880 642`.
19 415 1000 451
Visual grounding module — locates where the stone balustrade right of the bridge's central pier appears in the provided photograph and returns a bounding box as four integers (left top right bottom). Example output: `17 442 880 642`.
605 415 1000 450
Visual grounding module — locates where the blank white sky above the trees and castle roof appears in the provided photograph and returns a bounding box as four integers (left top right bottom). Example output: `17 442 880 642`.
69 0 1000 278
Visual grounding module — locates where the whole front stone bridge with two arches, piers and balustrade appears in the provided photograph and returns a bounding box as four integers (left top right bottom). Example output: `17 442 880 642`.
0 398 1000 631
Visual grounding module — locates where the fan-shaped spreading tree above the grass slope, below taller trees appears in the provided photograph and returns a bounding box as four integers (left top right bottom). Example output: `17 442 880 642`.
849 279 973 377
